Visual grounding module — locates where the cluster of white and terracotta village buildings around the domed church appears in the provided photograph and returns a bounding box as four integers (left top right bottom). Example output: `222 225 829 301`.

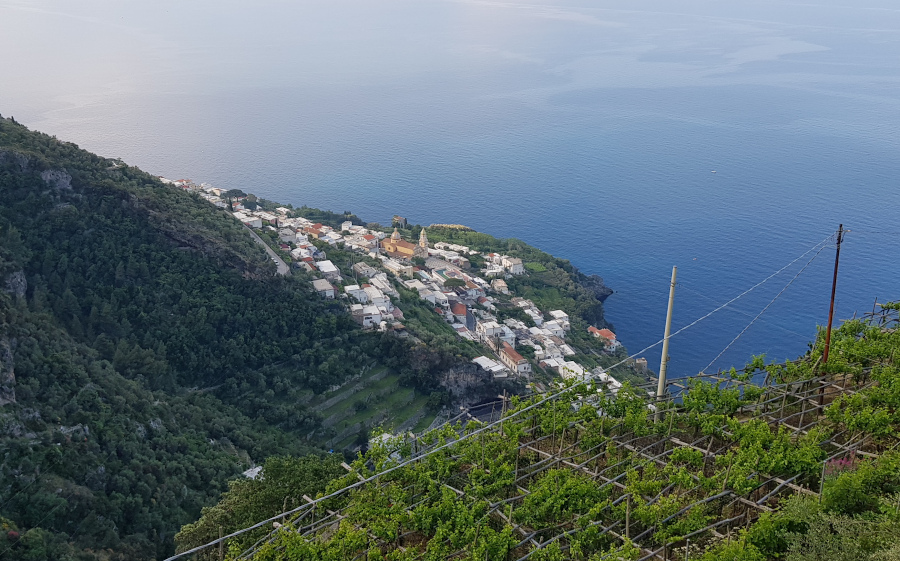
160 178 647 390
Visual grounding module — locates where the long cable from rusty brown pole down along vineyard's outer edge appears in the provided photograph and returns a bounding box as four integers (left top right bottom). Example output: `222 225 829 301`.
164 230 833 561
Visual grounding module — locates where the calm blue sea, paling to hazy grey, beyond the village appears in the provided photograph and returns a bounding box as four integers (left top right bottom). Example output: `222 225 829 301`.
0 0 900 377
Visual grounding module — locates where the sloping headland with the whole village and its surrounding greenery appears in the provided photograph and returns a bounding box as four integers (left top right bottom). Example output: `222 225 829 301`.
159 177 649 391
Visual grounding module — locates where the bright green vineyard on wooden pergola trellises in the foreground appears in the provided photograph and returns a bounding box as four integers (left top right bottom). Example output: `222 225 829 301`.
172 304 900 561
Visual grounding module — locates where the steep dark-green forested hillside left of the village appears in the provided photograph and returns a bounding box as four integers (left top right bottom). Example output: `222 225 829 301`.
0 118 457 560
